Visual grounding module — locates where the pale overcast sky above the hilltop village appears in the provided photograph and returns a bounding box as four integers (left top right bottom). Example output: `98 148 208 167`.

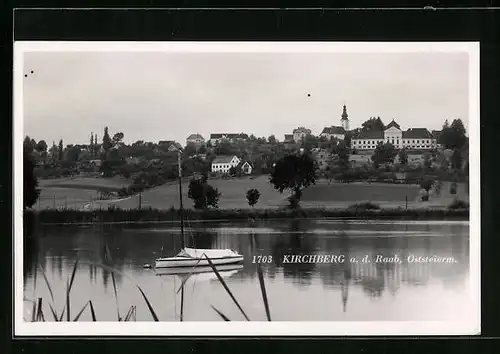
23 52 469 145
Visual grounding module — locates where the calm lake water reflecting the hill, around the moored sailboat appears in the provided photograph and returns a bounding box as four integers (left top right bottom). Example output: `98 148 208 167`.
24 219 475 321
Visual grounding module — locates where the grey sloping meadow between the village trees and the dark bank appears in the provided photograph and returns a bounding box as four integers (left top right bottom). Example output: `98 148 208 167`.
35 176 469 210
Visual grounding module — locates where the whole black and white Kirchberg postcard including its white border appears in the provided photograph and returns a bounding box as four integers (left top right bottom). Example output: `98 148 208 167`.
14 42 481 336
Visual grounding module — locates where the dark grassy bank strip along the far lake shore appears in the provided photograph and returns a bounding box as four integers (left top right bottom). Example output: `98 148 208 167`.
26 208 469 224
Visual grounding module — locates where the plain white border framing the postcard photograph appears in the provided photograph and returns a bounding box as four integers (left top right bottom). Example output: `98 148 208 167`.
12 41 481 337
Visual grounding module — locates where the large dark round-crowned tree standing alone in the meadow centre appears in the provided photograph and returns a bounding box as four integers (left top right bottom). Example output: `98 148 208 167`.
269 154 317 207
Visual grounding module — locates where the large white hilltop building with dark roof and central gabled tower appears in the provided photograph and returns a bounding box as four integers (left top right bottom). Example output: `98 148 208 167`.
351 120 437 150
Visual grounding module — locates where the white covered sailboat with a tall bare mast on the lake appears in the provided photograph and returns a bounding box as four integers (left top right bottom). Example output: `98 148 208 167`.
155 149 243 269
